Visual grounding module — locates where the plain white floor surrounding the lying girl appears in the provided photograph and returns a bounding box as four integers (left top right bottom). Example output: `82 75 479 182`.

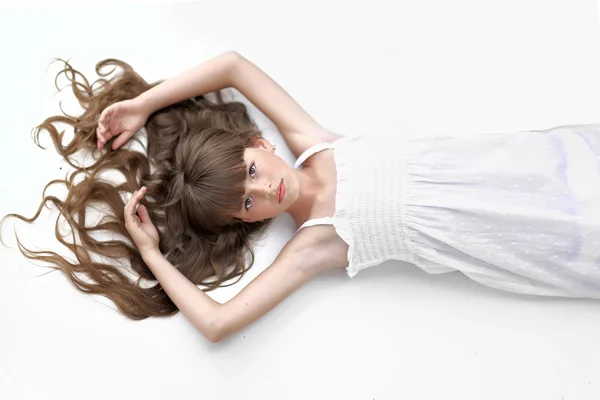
0 0 600 400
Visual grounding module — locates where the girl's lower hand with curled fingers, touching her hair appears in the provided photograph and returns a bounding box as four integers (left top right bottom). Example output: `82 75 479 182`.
125 186 160 255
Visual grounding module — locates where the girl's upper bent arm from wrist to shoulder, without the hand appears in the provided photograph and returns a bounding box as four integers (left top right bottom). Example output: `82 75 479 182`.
138 51 338 157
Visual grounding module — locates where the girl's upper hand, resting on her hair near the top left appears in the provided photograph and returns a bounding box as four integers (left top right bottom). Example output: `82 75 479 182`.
96 99 149 150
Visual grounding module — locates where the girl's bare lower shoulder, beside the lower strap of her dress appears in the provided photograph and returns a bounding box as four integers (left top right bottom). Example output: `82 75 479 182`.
277 225 348 273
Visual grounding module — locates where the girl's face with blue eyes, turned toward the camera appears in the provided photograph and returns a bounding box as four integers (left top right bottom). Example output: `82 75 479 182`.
236 139 299 222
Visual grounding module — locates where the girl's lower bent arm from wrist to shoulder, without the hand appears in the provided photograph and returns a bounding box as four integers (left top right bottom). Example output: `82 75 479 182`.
142 230 326 343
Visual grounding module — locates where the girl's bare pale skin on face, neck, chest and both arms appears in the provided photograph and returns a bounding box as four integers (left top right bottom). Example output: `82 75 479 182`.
103 52 348 342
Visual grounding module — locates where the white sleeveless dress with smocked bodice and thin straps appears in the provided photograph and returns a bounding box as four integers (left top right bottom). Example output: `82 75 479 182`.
295 124 600 298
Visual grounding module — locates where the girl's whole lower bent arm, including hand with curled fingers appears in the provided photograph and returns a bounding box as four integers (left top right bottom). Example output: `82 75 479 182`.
124 187 338 342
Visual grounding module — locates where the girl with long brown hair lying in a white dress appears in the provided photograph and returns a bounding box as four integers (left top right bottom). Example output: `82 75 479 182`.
7 52 600 342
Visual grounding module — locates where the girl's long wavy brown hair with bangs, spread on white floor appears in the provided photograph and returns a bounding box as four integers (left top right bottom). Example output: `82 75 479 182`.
0 59 270 319
